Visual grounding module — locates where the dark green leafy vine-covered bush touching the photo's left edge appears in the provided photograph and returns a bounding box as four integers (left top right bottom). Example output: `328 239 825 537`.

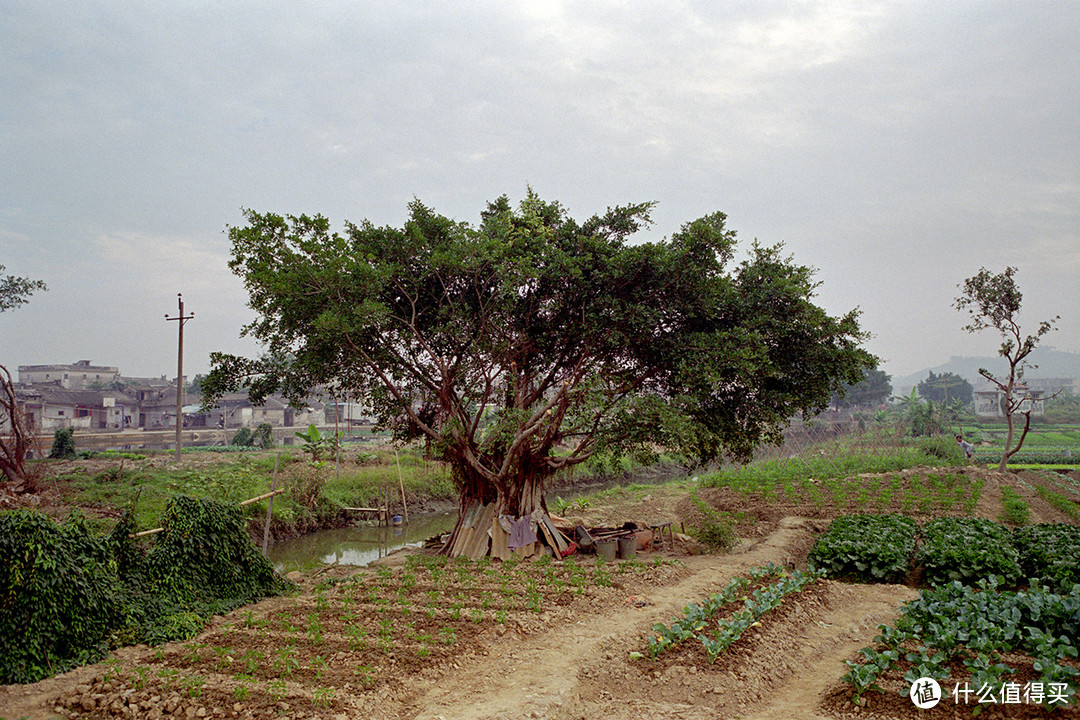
0 510 120 684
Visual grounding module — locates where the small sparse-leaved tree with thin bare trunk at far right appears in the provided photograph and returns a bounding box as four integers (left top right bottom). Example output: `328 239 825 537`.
954 267 1061 471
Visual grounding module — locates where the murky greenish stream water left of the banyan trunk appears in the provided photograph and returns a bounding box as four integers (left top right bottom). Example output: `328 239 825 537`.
267 513 457 572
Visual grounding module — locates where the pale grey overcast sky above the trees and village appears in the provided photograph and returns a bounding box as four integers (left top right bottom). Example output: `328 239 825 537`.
0 0 1080 377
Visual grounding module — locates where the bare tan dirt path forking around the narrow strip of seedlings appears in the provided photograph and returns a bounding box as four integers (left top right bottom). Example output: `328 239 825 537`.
405 518 916 720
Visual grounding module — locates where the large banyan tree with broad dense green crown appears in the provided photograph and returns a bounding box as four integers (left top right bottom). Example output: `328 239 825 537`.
203 191 874 552
